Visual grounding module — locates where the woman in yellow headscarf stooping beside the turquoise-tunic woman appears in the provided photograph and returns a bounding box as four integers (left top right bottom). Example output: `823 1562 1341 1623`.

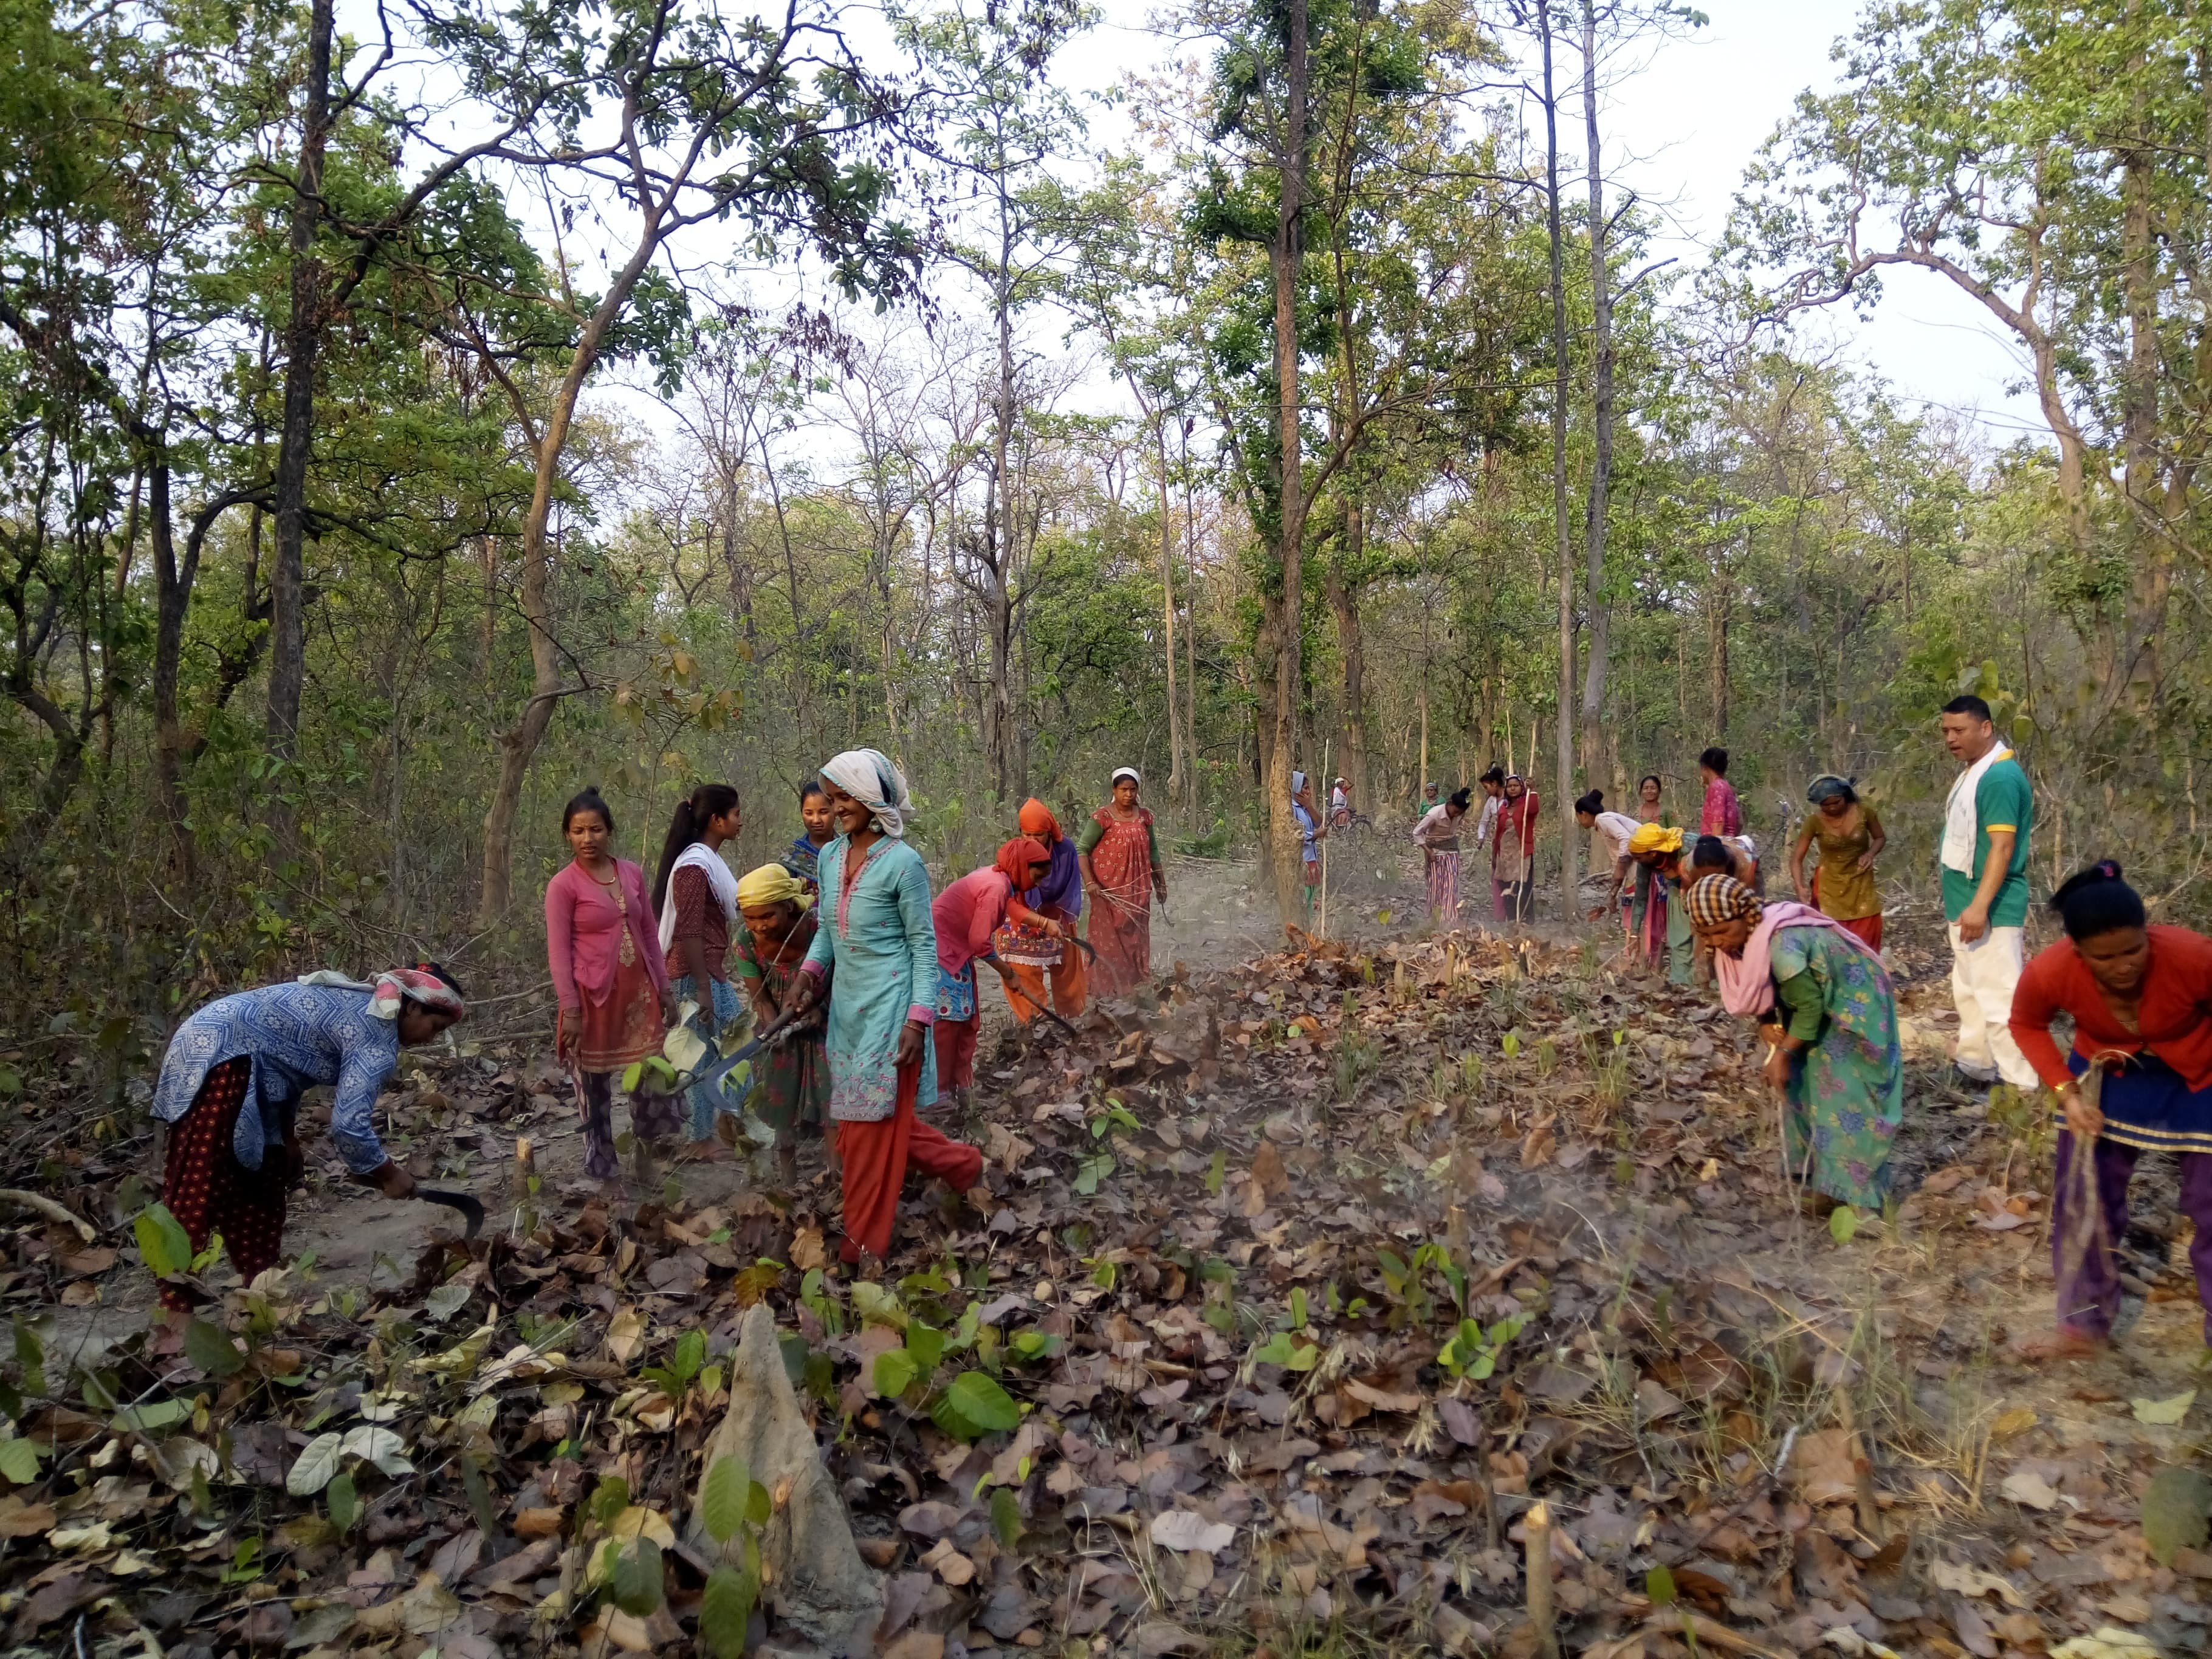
730 865 829 1183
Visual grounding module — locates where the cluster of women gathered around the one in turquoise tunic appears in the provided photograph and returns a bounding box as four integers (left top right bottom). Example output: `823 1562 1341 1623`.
546 750 1168 1261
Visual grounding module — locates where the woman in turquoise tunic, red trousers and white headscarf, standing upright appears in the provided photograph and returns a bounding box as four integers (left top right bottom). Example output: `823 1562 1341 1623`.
794 750 982 1263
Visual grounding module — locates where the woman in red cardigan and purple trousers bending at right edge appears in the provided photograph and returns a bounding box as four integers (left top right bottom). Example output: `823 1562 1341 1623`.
2011 858 2212 1358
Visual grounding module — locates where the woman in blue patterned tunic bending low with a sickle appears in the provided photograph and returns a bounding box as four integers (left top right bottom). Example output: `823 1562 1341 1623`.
153 962 464 1310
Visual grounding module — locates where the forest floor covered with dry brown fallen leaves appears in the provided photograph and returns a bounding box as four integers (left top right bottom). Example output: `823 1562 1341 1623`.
0 851 2212 1659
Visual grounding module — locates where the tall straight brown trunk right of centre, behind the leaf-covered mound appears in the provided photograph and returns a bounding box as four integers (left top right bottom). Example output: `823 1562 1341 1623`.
1265 0 1307 922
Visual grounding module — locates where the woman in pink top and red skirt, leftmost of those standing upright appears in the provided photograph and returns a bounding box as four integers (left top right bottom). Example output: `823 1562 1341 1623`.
546 789 681 1181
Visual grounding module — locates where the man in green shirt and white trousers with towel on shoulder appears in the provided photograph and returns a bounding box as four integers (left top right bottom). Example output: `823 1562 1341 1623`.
1942 697 2037 1088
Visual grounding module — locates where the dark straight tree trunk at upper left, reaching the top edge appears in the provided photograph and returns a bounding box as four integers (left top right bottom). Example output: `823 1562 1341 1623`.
267 0 334 787
